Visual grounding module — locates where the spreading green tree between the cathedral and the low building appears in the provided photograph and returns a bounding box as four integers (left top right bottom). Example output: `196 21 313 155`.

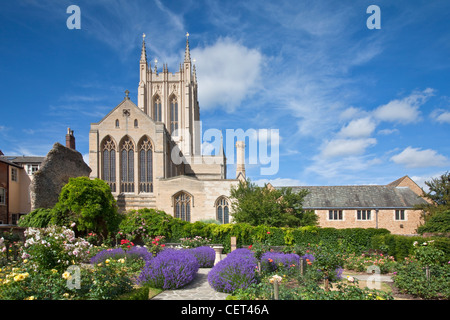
230 179 317 227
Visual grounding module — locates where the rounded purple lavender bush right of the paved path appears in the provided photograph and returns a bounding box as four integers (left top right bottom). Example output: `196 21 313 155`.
208 249 257 293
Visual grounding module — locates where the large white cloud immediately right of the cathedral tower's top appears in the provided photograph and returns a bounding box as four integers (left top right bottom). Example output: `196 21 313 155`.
191 38 263 111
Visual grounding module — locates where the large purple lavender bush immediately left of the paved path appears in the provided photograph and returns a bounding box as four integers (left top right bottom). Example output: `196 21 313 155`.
138 249 199 289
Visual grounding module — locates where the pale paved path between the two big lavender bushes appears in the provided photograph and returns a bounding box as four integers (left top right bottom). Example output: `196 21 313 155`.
152 268 229 300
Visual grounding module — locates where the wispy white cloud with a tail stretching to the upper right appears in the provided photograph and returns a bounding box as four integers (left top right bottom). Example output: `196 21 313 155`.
373 88 434 123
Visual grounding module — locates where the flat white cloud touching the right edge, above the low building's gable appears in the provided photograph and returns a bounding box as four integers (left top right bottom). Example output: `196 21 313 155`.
391 147 450 168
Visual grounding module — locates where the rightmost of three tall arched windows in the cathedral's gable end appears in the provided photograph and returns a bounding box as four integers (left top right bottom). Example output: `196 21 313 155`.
139 138 153 192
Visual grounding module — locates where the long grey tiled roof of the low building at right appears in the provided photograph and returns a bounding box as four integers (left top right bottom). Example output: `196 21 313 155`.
277 185 427 209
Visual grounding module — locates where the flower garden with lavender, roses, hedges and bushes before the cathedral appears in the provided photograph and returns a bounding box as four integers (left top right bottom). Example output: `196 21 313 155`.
0 177 450 300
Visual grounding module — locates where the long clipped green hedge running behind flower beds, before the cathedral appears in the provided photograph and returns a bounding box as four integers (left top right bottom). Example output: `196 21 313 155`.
120 209 389 253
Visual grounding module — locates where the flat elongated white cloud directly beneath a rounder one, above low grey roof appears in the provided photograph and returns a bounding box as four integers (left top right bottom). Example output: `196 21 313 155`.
322 138 377 158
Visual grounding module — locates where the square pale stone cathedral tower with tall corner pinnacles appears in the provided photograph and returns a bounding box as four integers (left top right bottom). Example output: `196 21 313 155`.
138 34 201 156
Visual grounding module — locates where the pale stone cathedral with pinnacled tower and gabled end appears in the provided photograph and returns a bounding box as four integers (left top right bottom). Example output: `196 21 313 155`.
89 35 245 223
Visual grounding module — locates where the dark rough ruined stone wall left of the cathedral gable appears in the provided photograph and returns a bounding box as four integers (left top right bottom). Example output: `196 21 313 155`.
30 143 91 210
